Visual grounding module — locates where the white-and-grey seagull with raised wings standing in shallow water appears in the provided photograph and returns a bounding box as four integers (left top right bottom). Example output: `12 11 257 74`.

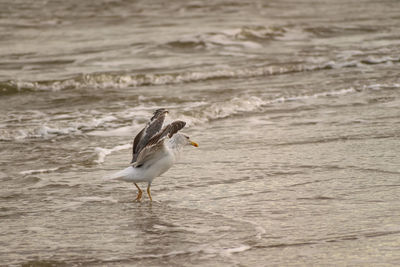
111 108 199 202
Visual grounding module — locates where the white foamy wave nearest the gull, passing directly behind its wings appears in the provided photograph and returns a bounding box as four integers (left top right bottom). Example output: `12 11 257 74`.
0 84 376 143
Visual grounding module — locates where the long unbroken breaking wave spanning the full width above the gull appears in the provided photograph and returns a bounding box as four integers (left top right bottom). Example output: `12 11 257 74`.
0 57 400 95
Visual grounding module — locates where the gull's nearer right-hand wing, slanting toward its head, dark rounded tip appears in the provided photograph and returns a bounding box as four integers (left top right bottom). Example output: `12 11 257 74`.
133 121 186 167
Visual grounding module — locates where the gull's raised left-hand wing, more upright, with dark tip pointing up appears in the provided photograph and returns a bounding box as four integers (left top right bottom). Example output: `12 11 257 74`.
131 109 168 163
